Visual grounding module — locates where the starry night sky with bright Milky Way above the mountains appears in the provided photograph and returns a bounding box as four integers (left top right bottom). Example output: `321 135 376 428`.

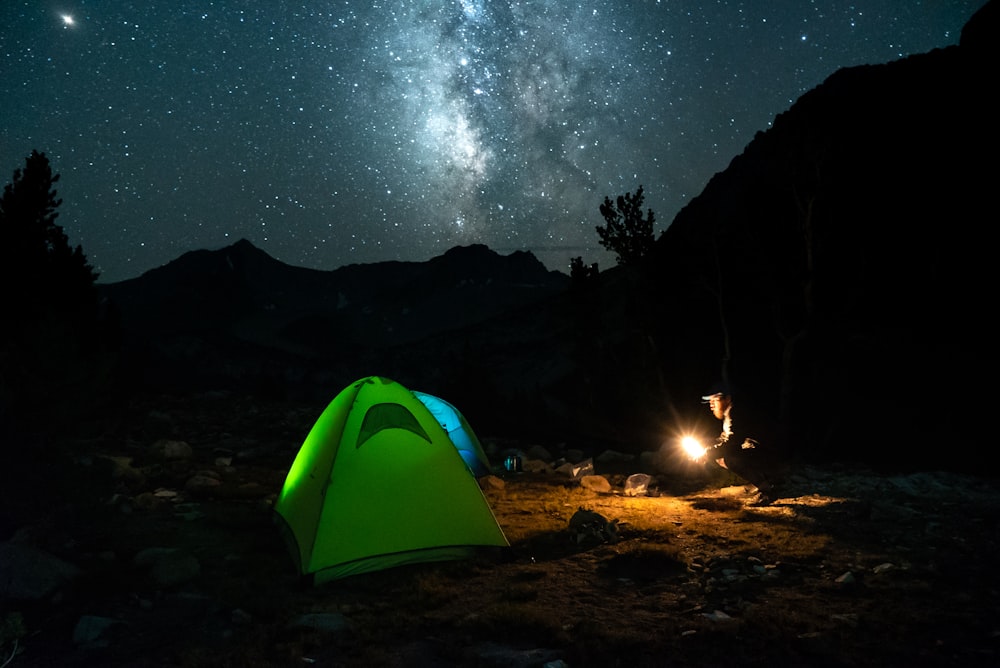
0 0 986 283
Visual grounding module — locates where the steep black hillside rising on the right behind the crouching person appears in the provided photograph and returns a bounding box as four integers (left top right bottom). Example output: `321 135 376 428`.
650 3 998 466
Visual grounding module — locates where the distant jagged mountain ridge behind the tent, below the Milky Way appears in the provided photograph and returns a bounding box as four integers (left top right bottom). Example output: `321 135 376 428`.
99 240 569 398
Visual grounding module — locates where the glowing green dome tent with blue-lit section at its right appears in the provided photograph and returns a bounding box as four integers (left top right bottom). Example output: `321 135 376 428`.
274 376 509 584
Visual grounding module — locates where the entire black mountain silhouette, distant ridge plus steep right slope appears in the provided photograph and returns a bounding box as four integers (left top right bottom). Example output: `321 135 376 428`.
92 0 1000 468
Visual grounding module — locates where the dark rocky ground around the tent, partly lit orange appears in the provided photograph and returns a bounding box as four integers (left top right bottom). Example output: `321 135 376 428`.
0 397 1000 668
